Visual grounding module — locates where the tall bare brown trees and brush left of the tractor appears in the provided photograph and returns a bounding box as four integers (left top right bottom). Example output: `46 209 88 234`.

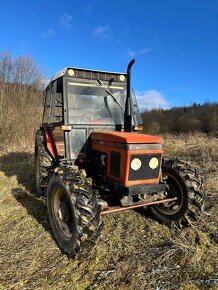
0 51 44 150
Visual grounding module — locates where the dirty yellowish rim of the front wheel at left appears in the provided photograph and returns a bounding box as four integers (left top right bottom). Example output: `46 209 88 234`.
51 187 74 240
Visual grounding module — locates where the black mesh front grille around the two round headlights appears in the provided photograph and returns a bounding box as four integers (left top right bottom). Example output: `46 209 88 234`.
128 153 161 181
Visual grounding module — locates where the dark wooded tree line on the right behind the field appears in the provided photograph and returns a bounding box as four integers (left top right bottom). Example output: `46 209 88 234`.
142 102 218 134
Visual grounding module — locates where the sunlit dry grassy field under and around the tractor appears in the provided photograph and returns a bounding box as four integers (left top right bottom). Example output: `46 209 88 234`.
0 134 218 290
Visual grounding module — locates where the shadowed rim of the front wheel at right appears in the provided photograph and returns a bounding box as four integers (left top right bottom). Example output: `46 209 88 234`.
155 172 184 215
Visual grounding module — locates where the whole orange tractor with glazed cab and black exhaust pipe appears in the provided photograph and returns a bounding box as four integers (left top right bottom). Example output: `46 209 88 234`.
35 59 204 257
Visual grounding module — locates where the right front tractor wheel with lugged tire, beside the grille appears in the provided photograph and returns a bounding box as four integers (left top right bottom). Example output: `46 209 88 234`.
148 158 204 229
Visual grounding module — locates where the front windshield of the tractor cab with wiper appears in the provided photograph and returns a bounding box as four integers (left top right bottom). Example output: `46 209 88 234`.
67 79 126 125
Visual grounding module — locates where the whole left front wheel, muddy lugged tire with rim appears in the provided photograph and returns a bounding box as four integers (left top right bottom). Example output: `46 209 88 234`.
47 166 103 257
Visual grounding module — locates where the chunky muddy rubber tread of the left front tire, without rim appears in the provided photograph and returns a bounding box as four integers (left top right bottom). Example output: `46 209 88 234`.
47 166 103 257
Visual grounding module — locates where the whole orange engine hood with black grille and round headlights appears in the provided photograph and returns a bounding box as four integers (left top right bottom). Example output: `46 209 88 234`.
91 131 163 186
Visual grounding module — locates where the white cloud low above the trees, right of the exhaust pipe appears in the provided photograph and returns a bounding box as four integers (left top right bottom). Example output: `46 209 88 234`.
136 90 169 110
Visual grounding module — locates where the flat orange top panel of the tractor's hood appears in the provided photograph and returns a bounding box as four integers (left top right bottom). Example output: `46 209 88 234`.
91 131 162 144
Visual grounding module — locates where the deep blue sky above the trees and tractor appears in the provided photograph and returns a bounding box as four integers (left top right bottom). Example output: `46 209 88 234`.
0 0 218 109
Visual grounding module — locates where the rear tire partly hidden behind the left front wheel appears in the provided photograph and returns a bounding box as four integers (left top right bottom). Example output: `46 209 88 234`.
35 130 52 196
